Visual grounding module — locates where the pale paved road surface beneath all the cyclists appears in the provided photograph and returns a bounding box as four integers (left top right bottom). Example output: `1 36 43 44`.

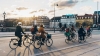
0 31 100 56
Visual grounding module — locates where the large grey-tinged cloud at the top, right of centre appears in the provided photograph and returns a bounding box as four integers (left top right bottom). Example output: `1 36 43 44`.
51 0 78 9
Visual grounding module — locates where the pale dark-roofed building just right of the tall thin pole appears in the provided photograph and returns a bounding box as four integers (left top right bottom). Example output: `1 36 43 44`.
50 16 61 28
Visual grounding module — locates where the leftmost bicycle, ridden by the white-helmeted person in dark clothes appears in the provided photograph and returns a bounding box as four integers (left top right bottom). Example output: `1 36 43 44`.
9 34 30 49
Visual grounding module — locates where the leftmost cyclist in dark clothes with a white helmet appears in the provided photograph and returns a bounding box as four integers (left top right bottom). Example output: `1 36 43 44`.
15 22 25 47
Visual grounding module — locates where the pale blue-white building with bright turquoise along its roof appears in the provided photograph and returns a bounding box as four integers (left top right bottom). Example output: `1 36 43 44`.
61 14 77 27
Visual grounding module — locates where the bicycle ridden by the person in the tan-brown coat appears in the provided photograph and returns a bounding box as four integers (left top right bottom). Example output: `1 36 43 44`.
34 34 53 49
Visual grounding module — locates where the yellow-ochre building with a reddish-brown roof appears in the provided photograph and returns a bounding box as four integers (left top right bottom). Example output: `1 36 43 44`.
76 14 93 27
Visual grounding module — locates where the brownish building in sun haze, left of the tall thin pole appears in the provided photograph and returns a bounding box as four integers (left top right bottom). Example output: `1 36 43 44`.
34 16 50 27
